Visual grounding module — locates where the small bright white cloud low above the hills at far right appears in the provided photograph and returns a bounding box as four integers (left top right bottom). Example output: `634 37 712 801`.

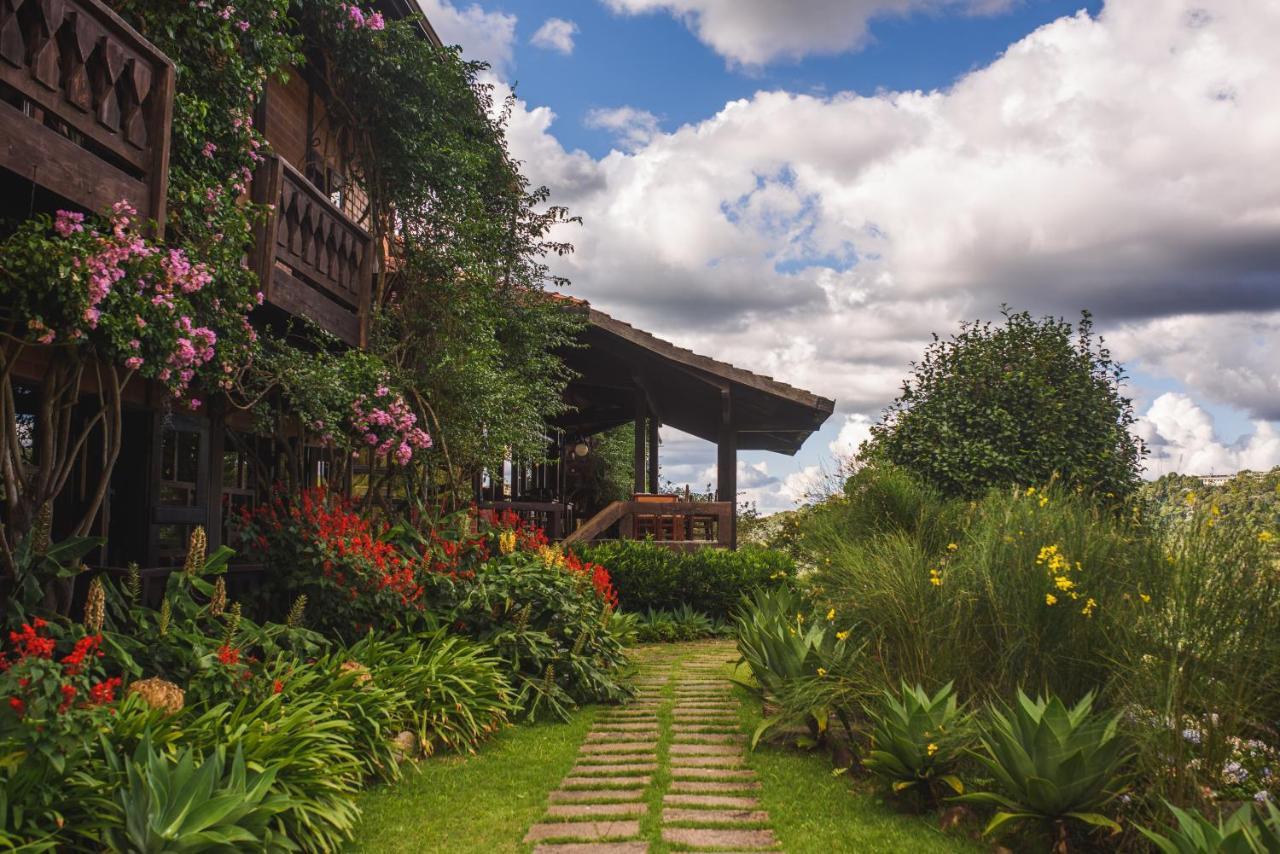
1134 392 1280 478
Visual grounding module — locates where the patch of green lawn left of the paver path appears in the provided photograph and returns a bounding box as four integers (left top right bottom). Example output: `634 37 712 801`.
351 709 595 854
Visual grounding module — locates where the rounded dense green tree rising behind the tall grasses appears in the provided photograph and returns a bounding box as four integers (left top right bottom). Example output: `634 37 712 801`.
861 307 1146 499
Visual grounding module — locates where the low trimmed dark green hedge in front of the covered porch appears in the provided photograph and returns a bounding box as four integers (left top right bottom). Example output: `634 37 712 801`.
576 540 796 620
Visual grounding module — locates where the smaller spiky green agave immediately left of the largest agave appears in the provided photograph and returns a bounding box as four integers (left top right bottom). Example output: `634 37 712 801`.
863 681 969 799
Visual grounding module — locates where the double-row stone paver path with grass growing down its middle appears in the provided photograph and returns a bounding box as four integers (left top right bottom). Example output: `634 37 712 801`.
525 641 781 854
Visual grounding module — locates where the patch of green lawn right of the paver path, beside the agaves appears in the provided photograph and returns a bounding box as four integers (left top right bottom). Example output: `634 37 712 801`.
726 667 988 854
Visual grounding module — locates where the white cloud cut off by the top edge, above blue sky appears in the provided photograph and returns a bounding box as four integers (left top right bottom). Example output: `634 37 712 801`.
604 0 1010 65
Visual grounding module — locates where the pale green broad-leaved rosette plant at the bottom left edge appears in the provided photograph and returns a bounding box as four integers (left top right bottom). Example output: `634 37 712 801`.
106 737 297 851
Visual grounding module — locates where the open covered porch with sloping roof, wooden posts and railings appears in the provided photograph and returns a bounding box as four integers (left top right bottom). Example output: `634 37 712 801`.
475 300 835 549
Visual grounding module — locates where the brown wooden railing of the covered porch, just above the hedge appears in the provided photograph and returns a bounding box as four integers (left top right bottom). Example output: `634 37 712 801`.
564 501 733 551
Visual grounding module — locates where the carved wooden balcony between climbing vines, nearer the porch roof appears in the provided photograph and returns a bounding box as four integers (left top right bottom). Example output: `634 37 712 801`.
249 155 374 347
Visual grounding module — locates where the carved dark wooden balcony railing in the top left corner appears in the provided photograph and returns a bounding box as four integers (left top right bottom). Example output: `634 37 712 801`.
0 0 174 228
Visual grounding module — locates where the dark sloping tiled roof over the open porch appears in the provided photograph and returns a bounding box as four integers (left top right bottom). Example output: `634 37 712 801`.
553 294 836 455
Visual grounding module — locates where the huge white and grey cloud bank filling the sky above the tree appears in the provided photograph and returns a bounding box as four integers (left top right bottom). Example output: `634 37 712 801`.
513 0 1280 448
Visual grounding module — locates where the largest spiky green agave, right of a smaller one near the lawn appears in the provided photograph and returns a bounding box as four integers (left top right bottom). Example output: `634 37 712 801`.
961 691 1129 854
